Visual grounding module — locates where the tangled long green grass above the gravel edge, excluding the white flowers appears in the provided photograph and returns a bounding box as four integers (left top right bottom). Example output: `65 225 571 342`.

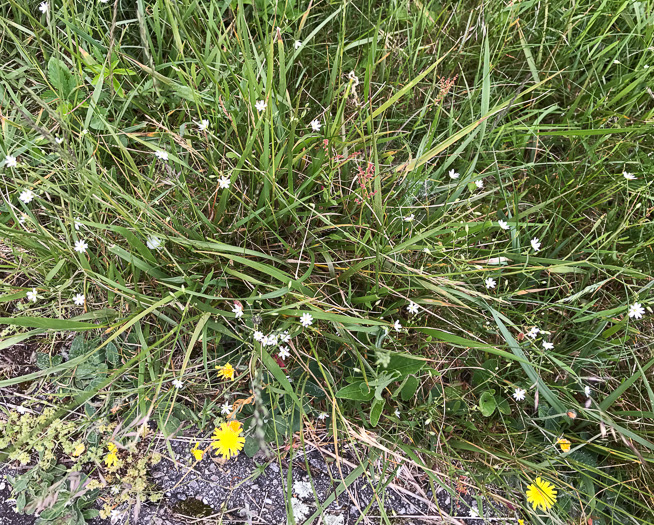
0 0 654 524
